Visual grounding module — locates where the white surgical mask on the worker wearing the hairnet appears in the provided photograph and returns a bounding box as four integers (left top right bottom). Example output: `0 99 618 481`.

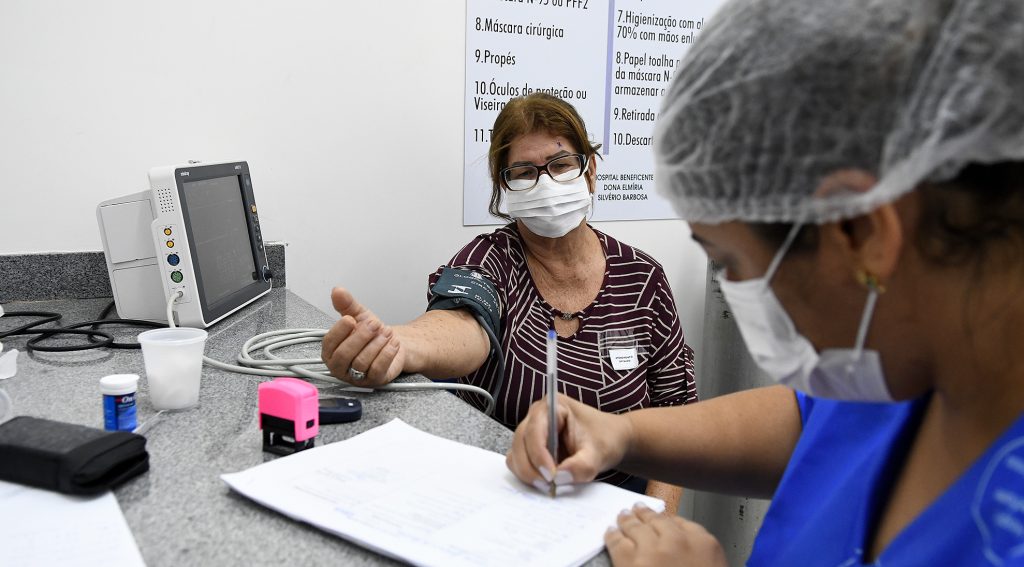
719 224 892 402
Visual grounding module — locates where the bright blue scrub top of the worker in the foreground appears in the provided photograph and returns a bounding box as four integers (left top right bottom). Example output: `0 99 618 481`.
748 393 1024 567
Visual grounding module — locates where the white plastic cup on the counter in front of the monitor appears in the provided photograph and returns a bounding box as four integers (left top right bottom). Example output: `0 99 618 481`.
138 326 206 409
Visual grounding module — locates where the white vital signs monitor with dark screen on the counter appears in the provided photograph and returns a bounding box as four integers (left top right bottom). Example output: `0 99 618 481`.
96 162 271 329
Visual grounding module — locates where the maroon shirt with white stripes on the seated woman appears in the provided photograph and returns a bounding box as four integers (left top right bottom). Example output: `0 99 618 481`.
428 223 697 484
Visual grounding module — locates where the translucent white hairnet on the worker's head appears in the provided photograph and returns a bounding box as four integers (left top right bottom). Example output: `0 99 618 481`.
654 0 1024 223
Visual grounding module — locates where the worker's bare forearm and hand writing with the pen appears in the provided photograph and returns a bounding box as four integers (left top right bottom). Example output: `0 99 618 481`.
507 386 802 497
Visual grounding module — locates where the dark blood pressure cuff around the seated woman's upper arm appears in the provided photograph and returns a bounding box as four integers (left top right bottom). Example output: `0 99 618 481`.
427 268 502 345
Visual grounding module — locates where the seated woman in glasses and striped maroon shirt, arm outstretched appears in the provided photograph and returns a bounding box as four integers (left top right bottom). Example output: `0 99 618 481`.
323 94 696 511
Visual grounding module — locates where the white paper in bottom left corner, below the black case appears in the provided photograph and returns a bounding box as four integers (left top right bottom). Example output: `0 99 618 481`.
0 481 145 567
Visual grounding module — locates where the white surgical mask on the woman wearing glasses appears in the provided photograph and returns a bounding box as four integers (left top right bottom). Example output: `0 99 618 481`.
505 175 593 234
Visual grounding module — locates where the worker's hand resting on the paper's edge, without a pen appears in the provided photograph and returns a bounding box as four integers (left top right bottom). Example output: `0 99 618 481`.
604 504 729 567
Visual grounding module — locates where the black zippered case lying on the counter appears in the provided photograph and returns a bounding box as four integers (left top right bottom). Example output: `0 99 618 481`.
0 416 150 494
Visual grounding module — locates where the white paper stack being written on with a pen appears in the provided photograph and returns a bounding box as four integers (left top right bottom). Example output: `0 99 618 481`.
221 420 665 566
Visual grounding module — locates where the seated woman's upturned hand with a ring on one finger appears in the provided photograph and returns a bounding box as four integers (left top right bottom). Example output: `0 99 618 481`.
321 288 404 387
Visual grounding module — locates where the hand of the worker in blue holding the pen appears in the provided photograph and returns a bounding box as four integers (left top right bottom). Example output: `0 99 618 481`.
505 394 632 492
